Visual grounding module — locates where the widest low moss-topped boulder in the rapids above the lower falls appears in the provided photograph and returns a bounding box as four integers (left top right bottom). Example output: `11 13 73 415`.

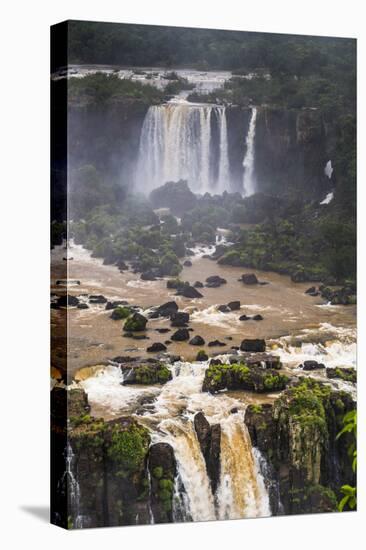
202 363 289 393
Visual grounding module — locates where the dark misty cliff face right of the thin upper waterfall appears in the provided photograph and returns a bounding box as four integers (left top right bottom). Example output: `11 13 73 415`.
255 107 332 199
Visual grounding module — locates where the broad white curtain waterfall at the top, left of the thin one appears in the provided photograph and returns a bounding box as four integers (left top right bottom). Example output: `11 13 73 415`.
136 102 230 194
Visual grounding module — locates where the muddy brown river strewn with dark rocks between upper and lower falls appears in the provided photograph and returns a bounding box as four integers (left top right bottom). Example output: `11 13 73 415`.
52 243 356 376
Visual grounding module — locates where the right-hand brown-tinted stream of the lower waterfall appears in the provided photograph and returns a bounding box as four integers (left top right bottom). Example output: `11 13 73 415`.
217 414 271 519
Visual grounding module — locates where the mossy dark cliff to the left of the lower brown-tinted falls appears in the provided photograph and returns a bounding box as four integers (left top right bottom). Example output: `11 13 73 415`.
52 388 175 528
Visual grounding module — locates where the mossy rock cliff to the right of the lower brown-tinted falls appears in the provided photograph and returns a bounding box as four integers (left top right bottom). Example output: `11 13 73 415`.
245 379 355 514
